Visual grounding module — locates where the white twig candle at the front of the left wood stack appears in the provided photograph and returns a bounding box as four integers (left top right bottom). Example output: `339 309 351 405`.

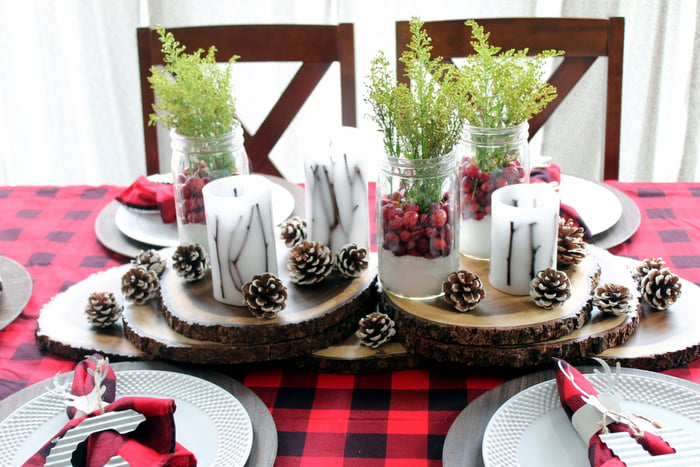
202 175 277 306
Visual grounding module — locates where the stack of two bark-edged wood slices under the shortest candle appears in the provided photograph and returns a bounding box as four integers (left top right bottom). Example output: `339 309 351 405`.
380 247 639 368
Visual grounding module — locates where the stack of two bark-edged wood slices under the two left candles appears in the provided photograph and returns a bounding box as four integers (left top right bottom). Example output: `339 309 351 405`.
124 250 376 363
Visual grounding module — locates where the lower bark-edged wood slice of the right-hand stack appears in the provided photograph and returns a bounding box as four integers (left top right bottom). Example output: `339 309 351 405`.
394 250 641 368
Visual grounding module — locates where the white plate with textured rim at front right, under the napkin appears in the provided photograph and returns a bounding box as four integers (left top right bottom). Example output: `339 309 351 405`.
482 374 700 467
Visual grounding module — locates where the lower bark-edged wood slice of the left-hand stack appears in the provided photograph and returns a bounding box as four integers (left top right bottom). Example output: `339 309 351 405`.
123 296 366 365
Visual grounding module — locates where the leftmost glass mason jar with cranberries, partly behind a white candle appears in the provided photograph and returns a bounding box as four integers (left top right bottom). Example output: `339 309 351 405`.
170 122 248 250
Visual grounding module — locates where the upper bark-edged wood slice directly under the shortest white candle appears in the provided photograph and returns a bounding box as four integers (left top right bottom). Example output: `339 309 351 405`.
381 249 600 346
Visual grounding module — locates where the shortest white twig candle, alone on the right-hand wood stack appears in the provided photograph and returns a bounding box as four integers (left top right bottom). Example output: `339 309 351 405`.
489 183 559 295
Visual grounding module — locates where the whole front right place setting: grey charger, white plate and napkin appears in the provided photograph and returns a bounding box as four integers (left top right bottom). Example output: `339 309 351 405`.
443 358 700 467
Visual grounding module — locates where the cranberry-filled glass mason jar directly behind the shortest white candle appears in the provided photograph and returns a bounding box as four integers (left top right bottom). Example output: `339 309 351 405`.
459 122 530 259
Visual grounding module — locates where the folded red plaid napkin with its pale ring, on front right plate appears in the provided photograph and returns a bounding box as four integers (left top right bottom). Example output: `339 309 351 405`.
552 358 676 467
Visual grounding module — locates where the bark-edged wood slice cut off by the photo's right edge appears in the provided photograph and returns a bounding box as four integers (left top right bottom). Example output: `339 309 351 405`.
597 258 700 371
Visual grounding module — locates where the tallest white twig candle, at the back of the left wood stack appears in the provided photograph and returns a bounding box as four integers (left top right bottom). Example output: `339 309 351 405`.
304 127 369 254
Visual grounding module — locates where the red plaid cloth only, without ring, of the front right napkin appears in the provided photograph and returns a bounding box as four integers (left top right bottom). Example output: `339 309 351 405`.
552 358 676 467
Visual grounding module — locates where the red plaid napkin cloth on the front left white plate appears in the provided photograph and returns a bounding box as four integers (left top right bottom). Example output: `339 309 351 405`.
24 357 197 467
